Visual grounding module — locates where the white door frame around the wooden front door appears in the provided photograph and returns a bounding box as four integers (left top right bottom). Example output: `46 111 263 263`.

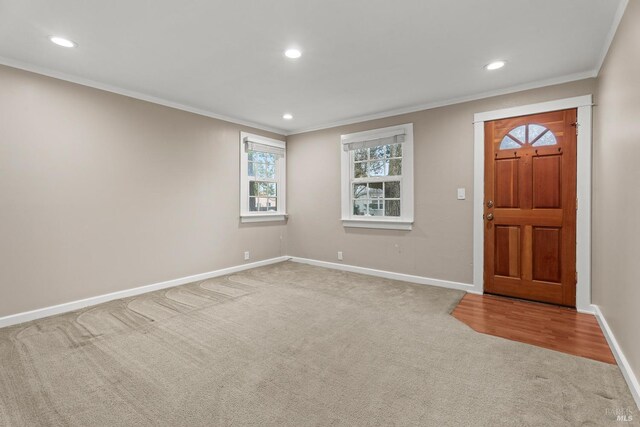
473 94 594 313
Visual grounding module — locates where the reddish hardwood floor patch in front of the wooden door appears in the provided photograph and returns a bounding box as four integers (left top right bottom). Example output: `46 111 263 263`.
451 294 616 364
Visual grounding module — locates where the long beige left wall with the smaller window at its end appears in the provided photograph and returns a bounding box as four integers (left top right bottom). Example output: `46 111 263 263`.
0 66 286 317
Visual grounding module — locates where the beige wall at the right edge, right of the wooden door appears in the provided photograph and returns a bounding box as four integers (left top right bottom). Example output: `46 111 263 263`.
592 0 640 394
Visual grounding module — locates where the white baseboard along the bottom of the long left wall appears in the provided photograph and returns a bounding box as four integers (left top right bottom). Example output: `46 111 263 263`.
0 256 290 328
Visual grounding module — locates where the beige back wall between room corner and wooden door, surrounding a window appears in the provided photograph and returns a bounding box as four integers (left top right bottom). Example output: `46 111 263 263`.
287 79 596 283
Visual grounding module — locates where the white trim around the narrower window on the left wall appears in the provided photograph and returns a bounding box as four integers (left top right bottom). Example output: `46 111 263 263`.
240 132 287 223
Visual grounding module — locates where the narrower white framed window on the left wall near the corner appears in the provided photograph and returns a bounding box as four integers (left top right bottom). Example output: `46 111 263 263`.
240 132 287 222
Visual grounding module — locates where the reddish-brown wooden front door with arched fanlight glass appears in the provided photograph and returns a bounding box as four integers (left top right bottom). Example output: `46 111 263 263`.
484 109 577 307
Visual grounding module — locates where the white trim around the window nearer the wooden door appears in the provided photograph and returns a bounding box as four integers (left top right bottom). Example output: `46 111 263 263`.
340 123 414 230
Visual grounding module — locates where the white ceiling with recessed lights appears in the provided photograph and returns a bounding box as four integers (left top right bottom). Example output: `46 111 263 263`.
0 0 626 133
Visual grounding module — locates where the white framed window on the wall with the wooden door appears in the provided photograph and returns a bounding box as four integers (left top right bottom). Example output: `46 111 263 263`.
340 123 413 230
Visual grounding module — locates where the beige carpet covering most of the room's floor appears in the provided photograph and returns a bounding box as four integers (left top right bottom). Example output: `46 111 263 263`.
0 262 638 426
